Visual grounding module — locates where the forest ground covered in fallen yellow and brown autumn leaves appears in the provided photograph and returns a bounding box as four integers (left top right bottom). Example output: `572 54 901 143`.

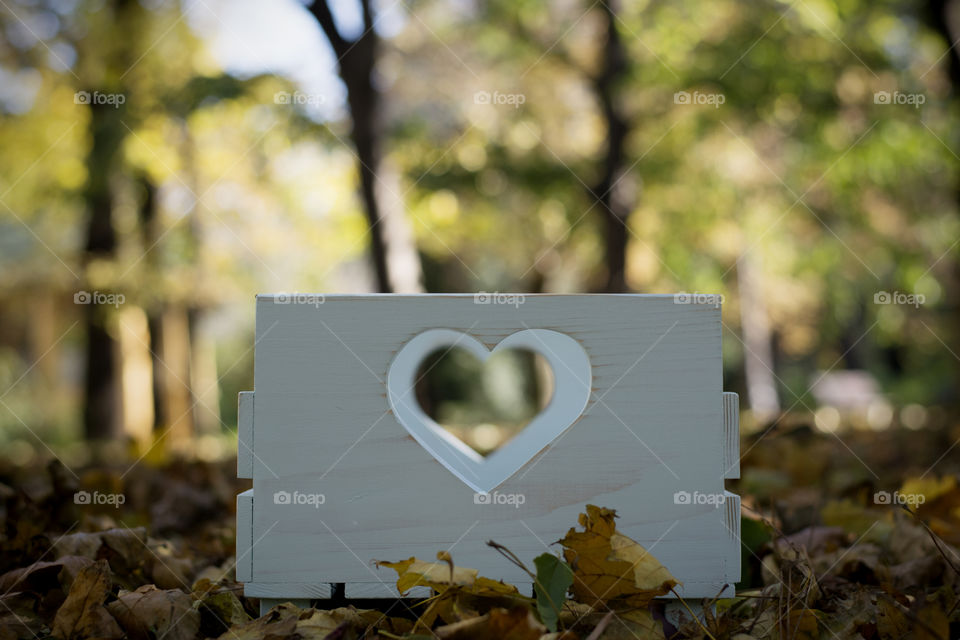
0 426 960 640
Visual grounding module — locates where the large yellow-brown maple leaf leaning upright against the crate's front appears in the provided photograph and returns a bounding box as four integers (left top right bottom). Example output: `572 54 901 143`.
560 505 679 608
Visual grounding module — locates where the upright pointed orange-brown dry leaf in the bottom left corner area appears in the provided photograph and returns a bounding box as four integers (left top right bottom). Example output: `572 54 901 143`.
53 560 123 640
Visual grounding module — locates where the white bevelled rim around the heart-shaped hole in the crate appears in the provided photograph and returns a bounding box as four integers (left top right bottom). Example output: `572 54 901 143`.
387 329 593 493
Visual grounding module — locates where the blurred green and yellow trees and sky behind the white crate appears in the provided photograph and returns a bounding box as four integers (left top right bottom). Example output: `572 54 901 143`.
0 0 960 475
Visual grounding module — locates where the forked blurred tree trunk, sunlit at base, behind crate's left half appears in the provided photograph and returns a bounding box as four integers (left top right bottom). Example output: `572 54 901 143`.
309 0 423 293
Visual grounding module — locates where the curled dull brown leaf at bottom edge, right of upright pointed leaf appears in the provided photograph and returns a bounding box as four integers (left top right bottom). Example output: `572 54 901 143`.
107 584 200 640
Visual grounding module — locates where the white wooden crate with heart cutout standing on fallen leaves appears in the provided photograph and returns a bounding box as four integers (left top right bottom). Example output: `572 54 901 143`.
236 294 740 599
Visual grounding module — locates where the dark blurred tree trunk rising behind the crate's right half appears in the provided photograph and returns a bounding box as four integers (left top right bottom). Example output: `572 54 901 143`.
592 0 635 293
